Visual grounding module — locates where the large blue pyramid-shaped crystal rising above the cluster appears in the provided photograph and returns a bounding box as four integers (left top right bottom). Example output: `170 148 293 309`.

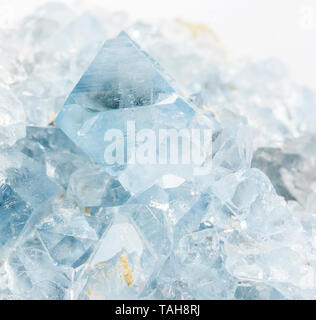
56 32 195 191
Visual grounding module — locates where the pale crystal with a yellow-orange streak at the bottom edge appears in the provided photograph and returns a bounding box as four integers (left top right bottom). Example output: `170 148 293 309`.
80 188 172 299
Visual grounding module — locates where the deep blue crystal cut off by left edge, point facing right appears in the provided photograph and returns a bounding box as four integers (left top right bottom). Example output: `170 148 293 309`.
0 149 60 257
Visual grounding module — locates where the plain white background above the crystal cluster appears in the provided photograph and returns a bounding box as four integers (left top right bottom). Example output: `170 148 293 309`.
0 0 316 89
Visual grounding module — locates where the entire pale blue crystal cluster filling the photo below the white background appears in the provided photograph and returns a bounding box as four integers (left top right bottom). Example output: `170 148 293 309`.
0 4 316 299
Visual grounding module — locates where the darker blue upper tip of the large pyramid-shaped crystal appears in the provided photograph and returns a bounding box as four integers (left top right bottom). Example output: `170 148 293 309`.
61 32 174 111
